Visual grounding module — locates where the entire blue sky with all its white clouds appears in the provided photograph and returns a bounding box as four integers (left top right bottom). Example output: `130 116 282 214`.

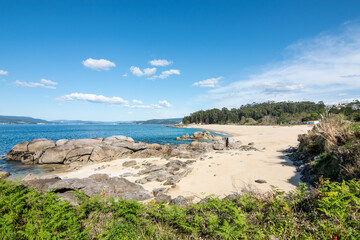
0 0 360 121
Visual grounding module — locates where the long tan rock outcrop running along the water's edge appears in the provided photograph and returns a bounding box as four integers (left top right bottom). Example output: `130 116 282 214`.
6 135 250 166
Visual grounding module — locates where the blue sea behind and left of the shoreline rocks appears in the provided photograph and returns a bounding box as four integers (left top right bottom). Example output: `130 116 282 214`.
0 124 221 179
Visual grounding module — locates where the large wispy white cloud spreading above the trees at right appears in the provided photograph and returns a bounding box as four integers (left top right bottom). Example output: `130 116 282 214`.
205 24 360 107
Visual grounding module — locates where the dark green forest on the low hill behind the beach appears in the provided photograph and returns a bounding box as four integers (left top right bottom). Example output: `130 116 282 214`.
183 101 326 125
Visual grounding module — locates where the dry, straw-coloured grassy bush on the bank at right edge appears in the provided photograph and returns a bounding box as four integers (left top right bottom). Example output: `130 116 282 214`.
298 114 360 181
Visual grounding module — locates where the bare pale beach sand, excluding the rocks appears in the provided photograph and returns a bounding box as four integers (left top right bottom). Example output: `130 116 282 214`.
58 125 311 198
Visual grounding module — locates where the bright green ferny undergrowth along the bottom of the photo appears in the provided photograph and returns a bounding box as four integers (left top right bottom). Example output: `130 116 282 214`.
0 179 360 239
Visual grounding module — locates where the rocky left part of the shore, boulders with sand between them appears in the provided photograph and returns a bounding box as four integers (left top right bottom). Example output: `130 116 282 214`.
2 131 257 204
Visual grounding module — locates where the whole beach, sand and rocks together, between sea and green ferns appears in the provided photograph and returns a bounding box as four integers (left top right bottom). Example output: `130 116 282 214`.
0 125 310 204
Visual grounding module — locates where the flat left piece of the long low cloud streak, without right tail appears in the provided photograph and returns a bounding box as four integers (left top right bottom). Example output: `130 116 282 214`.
56 93 129 105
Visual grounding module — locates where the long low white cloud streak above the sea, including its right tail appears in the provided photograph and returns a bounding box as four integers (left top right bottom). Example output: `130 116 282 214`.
56 93 172 109
